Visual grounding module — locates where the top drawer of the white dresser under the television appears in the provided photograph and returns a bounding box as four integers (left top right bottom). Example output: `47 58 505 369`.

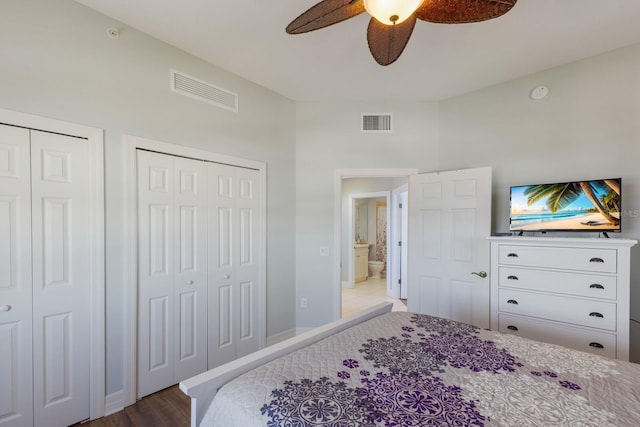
498 245 617 273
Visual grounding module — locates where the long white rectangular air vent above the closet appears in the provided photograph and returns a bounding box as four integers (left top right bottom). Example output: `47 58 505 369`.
171 70 238 113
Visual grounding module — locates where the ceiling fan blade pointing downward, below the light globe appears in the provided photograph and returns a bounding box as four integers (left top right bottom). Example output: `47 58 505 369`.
367 15 416 65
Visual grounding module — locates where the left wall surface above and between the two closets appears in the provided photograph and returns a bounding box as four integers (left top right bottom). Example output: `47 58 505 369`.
0 0 295 394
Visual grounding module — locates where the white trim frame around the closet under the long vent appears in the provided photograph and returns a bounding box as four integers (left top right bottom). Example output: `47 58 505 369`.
122 135 267 406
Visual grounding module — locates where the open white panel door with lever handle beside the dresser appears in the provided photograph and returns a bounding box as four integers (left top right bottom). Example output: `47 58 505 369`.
407 168 491 328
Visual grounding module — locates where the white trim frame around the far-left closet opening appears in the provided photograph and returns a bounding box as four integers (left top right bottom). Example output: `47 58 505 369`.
0 108 106 419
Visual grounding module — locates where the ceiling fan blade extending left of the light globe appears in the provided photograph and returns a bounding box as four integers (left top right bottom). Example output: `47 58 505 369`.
287 0 366 34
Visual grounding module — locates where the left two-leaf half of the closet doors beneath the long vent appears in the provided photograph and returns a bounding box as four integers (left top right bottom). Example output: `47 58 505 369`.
138 150 207 397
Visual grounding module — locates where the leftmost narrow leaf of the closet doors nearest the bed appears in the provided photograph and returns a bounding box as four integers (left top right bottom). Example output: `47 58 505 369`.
138 151 175 397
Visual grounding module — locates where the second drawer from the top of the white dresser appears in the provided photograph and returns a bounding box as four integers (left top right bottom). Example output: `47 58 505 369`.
498 267 617 300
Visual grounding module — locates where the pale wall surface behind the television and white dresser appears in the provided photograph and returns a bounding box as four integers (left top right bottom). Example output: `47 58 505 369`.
439 41 640 361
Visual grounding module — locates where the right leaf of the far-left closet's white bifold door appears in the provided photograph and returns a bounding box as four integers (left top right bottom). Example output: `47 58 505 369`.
31 131 91 426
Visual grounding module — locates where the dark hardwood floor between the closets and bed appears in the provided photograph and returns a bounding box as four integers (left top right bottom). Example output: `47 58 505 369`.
73 385 191 427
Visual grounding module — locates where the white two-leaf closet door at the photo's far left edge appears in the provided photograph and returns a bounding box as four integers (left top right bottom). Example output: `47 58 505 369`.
0 125 91 427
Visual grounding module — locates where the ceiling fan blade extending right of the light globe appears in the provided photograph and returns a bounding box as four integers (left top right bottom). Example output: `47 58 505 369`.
415 0 518 24
